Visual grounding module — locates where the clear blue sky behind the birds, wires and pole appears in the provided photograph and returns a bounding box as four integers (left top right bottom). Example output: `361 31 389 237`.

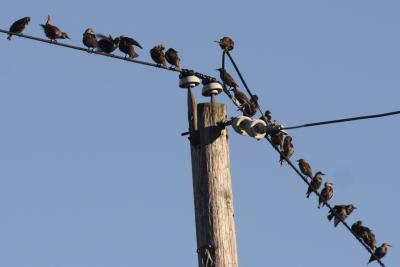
0 0 400 267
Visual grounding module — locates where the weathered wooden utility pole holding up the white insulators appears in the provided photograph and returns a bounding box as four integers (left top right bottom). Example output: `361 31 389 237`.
188 102 238 267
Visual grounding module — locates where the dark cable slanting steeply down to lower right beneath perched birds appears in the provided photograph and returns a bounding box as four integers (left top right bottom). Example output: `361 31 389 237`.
223 52 386 267
